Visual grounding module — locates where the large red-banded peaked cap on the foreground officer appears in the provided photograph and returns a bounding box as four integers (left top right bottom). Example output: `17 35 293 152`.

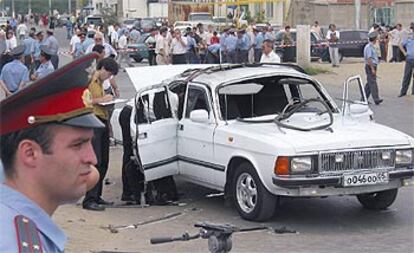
0 53 104 136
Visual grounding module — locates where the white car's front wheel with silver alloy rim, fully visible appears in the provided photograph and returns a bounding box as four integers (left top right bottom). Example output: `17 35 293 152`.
231 162 276 221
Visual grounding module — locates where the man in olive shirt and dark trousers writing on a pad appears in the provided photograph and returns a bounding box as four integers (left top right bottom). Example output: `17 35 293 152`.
82 57 118 211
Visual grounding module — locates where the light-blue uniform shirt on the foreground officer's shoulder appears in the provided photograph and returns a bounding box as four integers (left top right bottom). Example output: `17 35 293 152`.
0 184 67 253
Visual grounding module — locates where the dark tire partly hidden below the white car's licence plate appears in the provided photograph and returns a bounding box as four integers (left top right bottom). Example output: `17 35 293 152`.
357 189 398 210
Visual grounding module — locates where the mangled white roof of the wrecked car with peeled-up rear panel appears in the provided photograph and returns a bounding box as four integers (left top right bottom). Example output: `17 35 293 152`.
126 64 307 91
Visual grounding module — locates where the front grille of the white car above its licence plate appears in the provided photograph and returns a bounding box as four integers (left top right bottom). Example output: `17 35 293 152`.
319 149 395 172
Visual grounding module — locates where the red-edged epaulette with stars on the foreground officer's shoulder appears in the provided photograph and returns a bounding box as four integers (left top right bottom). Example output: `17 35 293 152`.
14 215 43 253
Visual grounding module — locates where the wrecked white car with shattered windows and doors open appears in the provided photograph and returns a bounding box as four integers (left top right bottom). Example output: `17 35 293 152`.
111 64 414 221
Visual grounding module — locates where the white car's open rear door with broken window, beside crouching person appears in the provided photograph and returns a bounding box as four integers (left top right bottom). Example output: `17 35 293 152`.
131 85 178 181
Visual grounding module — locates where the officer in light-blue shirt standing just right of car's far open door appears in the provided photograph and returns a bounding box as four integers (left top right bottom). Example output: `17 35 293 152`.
364 32 383 105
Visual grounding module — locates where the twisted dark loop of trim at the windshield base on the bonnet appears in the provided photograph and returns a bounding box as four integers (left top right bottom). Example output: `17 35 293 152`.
273 98 333 131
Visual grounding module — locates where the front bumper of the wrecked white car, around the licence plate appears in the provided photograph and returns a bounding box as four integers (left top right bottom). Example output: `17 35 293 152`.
272 166 414 196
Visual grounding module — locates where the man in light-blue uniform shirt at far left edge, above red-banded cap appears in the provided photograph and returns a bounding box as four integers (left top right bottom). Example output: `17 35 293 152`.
0 45 29 97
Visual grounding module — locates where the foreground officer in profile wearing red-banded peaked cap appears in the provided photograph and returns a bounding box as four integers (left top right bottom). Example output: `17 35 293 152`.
0 55 103 253
